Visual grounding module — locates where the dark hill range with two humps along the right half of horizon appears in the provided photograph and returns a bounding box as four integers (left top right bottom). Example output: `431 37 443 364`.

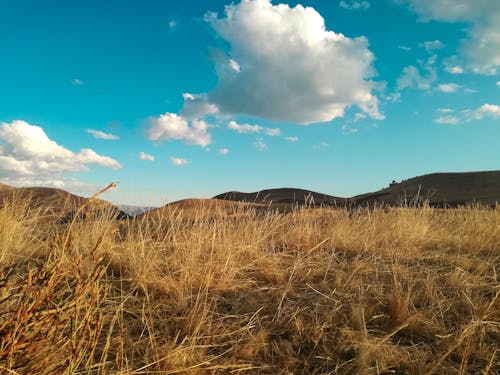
214 171 500 207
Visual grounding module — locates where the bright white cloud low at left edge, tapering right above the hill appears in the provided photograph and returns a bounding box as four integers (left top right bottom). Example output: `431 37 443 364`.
0 120 122 185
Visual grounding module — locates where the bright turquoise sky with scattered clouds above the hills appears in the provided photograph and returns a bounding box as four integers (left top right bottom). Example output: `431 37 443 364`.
0 0 500 206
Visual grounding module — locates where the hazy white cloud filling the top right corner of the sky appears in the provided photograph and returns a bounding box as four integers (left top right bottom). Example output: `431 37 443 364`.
403 0 500 74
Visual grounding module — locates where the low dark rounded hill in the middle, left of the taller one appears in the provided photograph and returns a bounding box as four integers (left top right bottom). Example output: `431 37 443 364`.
214 188 347 206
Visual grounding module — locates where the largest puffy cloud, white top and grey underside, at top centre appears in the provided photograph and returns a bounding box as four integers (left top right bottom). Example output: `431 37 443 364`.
206 0 383 124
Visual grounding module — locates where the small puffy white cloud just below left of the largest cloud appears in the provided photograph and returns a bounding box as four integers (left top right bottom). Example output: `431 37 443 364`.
148 112 212 147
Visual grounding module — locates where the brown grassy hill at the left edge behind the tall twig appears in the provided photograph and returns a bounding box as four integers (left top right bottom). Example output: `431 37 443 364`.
0 184 129 222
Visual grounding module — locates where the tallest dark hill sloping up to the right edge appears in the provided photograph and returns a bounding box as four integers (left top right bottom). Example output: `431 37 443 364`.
351 171 500 207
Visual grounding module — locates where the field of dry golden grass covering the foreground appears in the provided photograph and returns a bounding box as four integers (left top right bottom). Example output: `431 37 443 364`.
0 201 500 374
